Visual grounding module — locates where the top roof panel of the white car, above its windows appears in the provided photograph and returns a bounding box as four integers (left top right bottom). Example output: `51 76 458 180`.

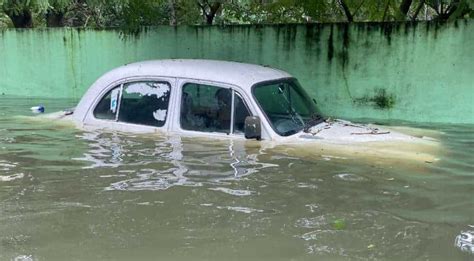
104 59 292 88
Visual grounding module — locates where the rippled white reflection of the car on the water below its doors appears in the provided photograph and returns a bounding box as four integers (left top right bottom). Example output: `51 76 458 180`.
74 132 278 191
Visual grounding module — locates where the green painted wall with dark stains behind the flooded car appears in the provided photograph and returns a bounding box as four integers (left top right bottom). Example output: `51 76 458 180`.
0 20 474 123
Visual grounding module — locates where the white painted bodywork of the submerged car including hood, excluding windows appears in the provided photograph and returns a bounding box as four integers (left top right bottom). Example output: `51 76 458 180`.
39 59 436 162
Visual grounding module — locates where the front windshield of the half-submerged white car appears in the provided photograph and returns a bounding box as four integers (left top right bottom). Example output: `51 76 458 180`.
253 79 323 136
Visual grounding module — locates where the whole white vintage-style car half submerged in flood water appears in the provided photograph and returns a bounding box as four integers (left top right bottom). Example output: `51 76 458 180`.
43 60 435 161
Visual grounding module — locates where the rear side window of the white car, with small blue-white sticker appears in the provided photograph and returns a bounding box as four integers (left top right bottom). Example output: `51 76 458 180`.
85 75 176 132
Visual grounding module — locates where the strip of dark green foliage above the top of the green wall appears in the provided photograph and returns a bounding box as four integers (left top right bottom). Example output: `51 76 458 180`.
0 0 474 28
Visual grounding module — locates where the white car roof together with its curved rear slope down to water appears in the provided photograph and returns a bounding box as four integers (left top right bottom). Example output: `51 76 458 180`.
74 59 292 122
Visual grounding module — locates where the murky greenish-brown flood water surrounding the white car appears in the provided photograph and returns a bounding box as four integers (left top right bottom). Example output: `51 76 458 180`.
0 96 474 260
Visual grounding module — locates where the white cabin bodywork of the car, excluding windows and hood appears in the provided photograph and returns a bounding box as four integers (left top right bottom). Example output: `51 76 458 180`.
73 60 286 140
